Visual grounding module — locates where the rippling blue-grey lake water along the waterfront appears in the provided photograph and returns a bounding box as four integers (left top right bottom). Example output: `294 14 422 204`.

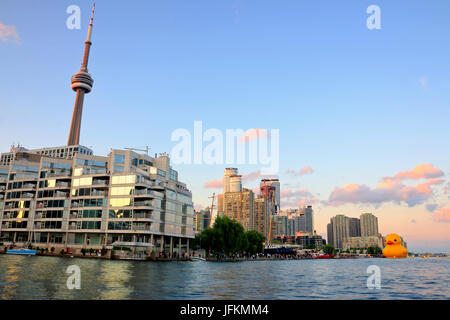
0 255 450 299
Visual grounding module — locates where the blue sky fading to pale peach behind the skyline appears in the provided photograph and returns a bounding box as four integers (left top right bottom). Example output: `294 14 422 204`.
0 0 450 250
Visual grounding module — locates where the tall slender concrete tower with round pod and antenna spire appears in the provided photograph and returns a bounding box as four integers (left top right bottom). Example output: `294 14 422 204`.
67 2 95 146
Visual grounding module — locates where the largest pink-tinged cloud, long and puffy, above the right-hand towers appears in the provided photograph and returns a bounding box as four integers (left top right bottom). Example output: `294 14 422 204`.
328 178 444 207
